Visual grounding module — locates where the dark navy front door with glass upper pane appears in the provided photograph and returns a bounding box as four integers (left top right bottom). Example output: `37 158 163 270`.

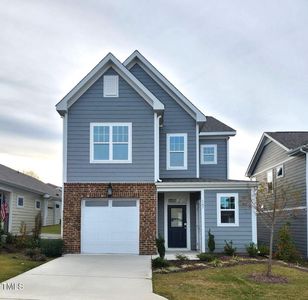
168 205 187 248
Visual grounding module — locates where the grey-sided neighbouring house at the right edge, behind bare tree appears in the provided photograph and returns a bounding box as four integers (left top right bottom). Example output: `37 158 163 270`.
246 131 308 257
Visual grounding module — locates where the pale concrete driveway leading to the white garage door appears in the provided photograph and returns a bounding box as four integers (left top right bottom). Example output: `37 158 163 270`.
0 255 165 300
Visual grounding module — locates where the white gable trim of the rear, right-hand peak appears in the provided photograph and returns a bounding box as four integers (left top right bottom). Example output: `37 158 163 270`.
123 50 206 122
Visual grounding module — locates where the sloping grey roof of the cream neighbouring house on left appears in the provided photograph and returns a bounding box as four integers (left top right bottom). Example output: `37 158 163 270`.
0 164 61 200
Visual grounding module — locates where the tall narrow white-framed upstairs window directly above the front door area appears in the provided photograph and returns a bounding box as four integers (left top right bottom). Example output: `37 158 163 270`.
167 133 187 170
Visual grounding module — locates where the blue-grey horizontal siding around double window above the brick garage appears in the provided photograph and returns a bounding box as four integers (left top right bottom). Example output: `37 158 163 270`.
67 68 154 182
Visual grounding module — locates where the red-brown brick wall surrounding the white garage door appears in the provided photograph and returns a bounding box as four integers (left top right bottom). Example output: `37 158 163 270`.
63 183 156 254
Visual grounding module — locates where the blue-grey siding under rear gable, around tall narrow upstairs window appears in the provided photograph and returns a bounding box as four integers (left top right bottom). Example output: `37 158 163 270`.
130 64 196 178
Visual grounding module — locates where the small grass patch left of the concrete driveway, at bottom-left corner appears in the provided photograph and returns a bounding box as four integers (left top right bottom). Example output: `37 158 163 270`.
0 253 43 282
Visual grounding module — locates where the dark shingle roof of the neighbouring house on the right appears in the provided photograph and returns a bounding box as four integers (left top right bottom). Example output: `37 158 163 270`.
266 131 308 149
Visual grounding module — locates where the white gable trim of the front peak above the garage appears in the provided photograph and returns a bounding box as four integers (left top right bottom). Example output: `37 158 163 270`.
56 53 164 115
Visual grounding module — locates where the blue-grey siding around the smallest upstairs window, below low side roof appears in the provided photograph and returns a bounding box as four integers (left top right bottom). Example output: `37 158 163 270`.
199 138 228 179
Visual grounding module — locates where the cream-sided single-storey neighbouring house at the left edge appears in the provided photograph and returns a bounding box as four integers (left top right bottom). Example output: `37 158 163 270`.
0 165 61 234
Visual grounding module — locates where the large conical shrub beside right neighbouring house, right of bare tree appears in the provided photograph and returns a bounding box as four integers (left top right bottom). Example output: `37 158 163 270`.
275 223 300 262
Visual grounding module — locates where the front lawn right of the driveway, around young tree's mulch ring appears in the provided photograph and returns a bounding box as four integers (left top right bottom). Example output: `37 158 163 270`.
153 264 308 300
